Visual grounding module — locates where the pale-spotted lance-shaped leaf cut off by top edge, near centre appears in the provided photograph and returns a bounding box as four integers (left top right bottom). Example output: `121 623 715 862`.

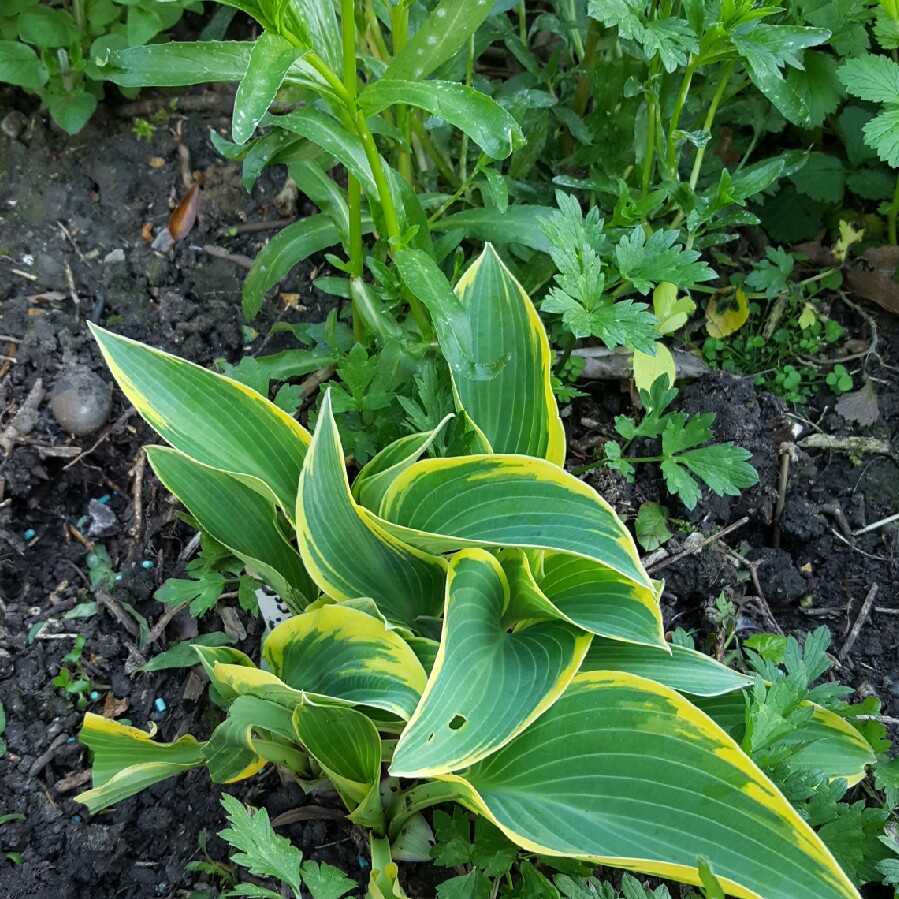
383 0 493 81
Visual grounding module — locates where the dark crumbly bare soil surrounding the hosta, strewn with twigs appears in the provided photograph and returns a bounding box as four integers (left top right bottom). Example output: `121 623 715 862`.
0 79 899 899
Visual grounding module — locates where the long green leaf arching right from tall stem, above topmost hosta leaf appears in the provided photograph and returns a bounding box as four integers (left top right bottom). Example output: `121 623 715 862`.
359 78 525 159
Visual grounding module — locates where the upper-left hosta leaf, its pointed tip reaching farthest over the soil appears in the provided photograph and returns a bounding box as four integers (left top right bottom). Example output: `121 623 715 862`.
88 323 309 519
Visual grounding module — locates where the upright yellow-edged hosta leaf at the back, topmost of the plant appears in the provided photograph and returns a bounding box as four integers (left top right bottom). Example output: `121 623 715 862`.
451 244 565 465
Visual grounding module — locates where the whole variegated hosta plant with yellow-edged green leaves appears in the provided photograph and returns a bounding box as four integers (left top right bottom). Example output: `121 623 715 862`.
80 247 873 899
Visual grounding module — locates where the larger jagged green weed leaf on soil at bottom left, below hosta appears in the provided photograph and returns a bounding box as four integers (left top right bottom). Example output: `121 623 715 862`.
219 793 303 896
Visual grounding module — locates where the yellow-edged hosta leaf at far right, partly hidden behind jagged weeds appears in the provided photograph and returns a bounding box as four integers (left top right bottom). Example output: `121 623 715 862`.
695 692 875 786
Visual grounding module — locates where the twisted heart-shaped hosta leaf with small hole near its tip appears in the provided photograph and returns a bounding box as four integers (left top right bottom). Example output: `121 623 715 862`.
390 550 591 777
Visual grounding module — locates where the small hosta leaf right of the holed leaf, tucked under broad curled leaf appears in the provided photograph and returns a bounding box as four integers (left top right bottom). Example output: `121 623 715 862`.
537 553 669 653
